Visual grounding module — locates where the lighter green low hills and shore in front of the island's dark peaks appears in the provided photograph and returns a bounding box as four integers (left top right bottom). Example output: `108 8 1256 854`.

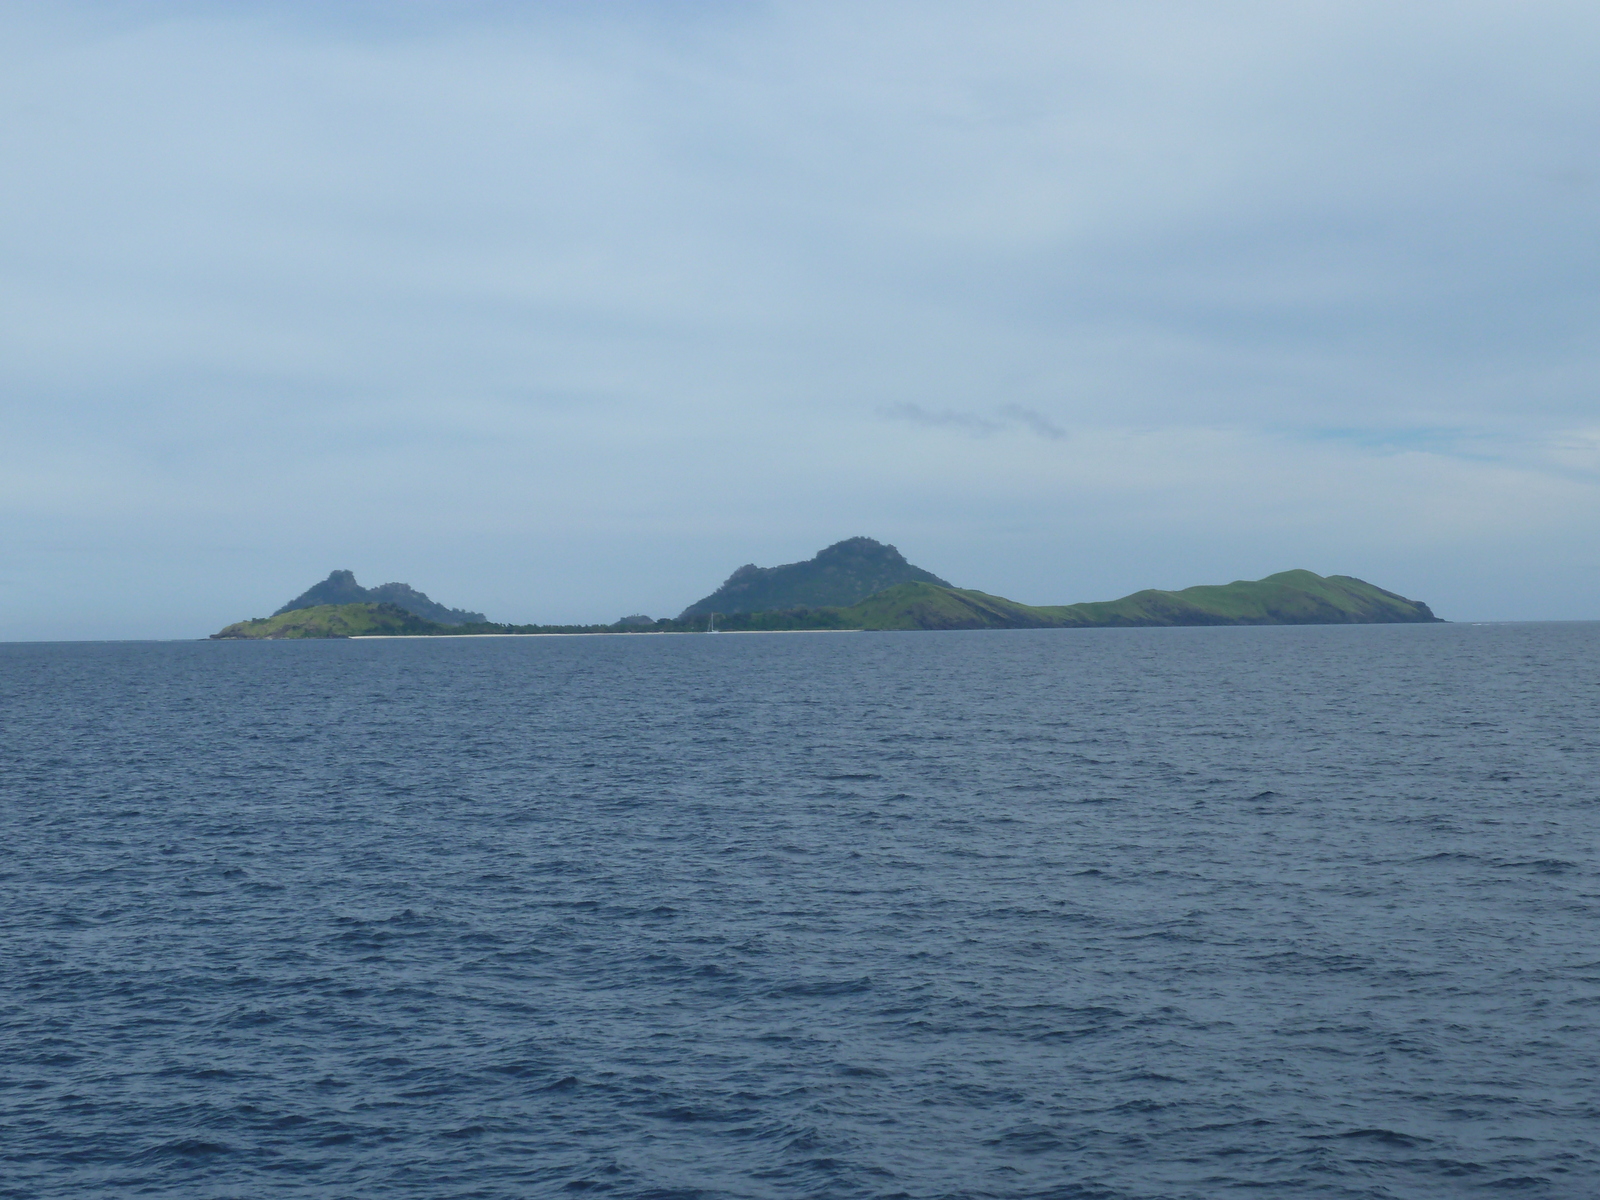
211 563 1440 638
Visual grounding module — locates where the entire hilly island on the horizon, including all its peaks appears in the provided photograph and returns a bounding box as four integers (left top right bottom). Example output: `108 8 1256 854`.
211 538 1440 640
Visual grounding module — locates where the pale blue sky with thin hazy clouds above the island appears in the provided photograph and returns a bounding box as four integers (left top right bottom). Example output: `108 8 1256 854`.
0 0 1600 640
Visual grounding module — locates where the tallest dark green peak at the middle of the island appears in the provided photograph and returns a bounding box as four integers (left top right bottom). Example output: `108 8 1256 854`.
678 538 949 629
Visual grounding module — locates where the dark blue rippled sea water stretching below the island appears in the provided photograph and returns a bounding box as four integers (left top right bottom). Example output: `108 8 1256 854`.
0 624 1600 1200
